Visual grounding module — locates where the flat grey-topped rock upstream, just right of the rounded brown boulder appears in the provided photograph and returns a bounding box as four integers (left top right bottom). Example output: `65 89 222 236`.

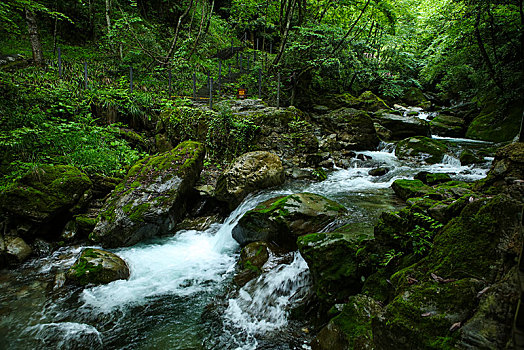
373 112 431 140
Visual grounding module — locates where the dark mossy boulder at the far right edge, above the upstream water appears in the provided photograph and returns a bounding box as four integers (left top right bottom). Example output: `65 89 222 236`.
466 103 522 142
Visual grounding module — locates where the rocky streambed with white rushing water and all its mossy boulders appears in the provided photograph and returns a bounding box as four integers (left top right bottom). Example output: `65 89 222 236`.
0 95 524 349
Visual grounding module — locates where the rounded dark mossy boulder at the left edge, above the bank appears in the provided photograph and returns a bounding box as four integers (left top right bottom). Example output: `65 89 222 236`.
0 165 92 239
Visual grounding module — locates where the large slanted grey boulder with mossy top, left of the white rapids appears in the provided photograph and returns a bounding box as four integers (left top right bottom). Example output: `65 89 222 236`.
90 141 204 247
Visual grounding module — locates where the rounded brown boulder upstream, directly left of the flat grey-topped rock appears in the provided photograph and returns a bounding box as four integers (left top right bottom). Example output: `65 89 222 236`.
317 108 380 151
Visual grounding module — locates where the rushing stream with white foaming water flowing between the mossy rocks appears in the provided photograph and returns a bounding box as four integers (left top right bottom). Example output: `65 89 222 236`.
0 138 491 349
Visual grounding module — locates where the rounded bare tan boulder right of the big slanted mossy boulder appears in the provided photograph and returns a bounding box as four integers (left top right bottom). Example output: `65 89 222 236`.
215 151 285 210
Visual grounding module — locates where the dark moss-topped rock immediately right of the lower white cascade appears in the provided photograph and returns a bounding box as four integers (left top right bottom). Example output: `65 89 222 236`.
297 232 367 305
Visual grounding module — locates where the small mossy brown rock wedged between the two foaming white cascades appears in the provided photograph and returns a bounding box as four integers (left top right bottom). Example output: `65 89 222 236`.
233 242 270 286
